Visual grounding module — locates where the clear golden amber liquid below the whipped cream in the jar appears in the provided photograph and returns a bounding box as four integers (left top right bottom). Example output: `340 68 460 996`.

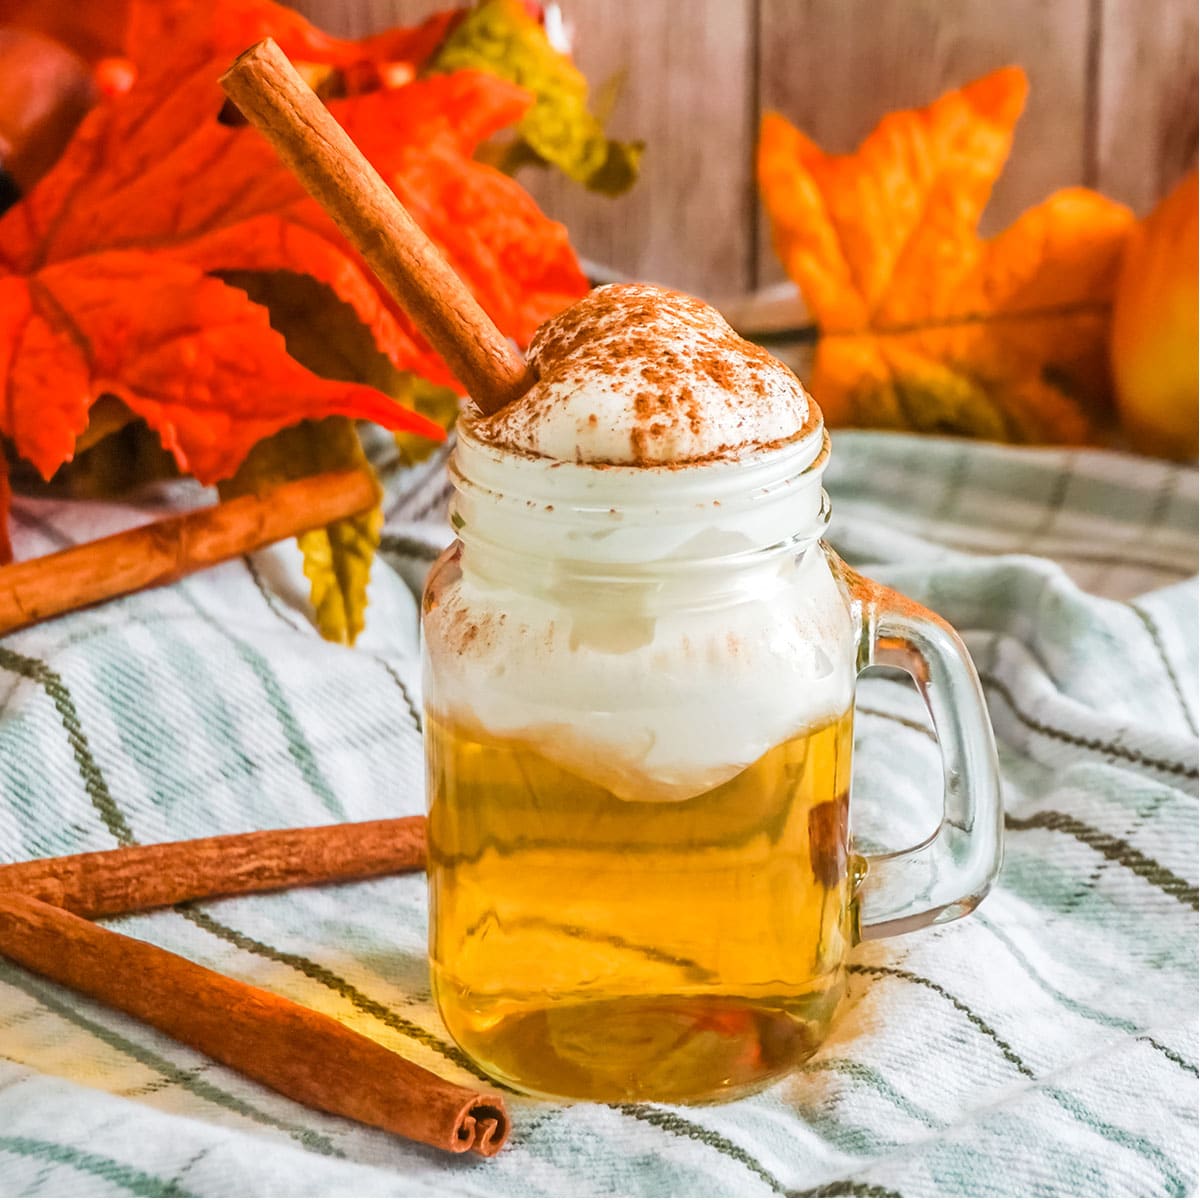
426 713 852 1102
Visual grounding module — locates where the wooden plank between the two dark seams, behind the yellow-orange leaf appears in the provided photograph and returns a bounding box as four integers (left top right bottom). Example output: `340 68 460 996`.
758 0 1090 284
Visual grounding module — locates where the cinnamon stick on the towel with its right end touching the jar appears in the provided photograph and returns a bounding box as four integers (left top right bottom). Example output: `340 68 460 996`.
0 817 425 917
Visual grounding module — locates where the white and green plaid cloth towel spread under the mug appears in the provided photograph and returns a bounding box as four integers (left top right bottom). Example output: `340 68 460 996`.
0 433 1198 1196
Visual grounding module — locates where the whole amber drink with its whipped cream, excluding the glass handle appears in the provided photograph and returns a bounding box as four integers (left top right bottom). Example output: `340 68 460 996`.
422 287 856 1100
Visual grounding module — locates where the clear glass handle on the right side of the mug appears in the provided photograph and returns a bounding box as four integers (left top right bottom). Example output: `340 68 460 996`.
839 564 1004 941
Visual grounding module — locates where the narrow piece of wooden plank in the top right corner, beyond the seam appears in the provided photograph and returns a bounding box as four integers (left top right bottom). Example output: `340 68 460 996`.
1094 0 1196 214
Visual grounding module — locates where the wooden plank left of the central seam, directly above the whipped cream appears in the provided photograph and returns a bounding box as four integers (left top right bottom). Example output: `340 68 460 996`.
521 0 757 295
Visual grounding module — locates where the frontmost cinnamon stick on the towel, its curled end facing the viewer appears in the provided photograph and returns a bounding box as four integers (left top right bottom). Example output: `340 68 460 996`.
0 893 509 1157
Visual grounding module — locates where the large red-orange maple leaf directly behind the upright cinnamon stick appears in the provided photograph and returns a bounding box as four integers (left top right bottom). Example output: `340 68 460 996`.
0 24 587 556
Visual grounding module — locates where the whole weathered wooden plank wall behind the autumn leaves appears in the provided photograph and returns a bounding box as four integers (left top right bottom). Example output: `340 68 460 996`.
288 0 1198 298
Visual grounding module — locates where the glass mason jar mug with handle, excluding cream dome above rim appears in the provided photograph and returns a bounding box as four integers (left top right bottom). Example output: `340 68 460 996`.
422 421 1001 1102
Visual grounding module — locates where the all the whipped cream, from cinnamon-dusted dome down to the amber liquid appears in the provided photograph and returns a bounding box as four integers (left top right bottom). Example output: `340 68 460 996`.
424 286 857 803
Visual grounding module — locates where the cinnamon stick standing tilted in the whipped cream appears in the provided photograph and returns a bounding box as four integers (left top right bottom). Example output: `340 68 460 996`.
221 38 533 413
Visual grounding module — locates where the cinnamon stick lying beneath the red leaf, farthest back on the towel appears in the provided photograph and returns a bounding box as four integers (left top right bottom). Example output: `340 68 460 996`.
0 470 378 635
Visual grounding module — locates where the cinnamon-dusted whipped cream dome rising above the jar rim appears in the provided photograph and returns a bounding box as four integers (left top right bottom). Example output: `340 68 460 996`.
469 283 815 467
